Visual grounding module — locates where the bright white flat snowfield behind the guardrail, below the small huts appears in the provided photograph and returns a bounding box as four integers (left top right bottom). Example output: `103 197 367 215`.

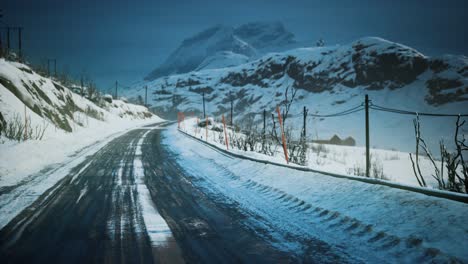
181 118 460 189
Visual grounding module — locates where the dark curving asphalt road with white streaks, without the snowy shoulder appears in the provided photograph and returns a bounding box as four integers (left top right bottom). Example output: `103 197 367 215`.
0 126 314 263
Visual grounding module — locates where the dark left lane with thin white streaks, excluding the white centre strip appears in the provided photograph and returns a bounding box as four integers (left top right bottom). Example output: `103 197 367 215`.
0 130 153 263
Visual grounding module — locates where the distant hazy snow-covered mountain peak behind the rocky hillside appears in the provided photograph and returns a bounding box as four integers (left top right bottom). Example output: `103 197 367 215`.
145 22 296 80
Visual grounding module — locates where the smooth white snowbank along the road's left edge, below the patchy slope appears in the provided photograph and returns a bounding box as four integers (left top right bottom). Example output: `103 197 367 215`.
0 116 163 188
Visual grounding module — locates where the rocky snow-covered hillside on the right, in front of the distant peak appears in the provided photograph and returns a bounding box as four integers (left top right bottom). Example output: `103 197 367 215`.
129 37 468 151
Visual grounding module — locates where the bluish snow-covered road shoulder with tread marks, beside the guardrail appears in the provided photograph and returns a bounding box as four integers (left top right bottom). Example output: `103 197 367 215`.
163 127 468 263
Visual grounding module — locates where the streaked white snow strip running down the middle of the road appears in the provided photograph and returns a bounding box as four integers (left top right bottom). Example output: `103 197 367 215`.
107 127 183 263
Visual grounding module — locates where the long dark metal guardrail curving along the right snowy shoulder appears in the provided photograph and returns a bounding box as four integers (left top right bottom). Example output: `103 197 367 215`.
178 129 468 203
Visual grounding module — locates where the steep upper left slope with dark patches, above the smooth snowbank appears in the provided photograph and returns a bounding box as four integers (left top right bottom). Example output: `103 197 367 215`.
0 59 153 135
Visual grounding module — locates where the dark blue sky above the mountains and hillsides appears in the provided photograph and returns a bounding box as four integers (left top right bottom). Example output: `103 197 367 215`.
0 0 468 89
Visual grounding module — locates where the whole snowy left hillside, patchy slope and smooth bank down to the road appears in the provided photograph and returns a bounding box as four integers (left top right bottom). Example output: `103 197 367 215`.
0 59 162 188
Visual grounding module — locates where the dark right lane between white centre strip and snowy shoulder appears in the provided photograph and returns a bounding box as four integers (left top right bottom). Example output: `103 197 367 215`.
142 131 297 263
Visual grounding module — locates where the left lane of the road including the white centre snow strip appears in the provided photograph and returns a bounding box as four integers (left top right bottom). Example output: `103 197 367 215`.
0 125 183 263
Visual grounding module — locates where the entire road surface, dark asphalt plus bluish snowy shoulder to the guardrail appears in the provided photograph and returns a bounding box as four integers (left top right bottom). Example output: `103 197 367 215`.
0 122 468 263
